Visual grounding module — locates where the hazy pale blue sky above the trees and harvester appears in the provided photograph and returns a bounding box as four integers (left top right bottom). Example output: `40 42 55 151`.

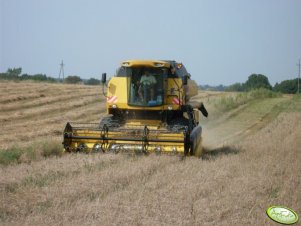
0 0 301 85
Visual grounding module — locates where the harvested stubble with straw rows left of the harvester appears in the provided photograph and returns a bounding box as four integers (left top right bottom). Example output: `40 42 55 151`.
0 81 105 150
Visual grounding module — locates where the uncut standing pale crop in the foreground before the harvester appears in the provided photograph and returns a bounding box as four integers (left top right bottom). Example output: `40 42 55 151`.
0 112 301 225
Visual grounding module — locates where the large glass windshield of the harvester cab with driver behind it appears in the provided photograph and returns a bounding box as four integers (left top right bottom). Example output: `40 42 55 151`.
126 67 168 106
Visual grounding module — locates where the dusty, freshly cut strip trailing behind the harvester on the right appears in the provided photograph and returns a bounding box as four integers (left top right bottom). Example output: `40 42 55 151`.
203 96 291 149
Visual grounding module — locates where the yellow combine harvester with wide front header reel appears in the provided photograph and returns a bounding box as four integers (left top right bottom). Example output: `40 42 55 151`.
63 60 208 156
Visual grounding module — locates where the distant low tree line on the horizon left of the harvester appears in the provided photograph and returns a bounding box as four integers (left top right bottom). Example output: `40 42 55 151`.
0 67 100 85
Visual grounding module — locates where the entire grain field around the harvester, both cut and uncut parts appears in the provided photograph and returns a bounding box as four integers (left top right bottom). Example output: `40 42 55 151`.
0 81 301 225
